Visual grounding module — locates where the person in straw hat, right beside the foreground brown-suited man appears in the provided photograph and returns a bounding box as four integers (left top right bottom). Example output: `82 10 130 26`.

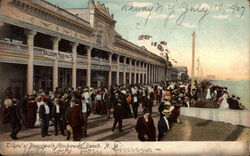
158 109 171 141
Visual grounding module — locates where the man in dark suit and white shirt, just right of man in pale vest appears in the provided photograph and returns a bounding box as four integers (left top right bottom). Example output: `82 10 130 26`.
52 98 65 136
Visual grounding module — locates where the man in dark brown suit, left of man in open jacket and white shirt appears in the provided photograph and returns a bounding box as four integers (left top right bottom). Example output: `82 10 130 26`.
69 100 83 141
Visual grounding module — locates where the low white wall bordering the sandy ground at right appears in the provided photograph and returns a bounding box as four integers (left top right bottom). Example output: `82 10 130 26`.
181 107 250 127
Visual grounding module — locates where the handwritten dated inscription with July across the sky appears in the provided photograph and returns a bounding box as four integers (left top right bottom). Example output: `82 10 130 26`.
121 0 246 28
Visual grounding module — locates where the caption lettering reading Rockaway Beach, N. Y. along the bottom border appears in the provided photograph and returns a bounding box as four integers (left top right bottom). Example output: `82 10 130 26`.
5 141 153 156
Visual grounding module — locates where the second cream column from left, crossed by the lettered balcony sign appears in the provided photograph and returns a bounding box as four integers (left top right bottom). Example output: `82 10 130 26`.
52 37 61 91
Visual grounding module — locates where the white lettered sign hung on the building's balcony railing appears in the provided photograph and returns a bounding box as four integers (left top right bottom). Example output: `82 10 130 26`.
42 49 73 62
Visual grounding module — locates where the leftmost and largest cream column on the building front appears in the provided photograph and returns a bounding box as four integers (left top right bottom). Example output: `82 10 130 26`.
25 30 37 95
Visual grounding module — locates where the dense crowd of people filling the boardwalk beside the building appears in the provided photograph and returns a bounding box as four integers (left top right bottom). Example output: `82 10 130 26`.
0 81 245 141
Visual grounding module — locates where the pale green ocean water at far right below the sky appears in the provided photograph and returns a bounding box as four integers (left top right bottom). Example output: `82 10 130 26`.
212 80 250 110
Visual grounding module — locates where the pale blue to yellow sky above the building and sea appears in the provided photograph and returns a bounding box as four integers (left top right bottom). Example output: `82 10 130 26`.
48 0 250 80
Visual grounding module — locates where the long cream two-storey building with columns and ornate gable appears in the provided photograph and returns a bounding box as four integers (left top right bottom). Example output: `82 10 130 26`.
0 0 167 96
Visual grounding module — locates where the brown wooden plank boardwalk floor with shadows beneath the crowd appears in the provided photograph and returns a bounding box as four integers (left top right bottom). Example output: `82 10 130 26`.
0 106 159 141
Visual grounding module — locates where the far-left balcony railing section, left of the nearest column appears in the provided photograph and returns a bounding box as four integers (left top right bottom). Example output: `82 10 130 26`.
0 40 29 54
